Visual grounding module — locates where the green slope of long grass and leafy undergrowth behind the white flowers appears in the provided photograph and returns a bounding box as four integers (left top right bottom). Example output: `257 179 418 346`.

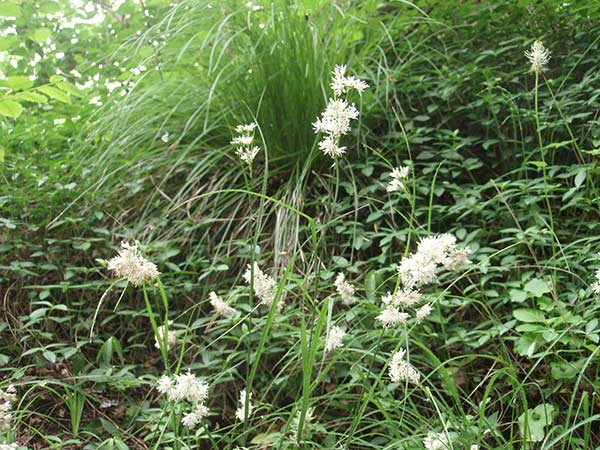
2 2 599 448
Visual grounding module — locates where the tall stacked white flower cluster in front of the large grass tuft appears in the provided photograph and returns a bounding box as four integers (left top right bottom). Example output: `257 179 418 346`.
313 66 369 158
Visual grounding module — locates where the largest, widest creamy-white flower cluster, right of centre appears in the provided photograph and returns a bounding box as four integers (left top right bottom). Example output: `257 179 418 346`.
398 233 471 288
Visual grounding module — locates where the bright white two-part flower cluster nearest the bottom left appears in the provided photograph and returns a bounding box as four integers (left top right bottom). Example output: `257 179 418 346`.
156 372 208 429
